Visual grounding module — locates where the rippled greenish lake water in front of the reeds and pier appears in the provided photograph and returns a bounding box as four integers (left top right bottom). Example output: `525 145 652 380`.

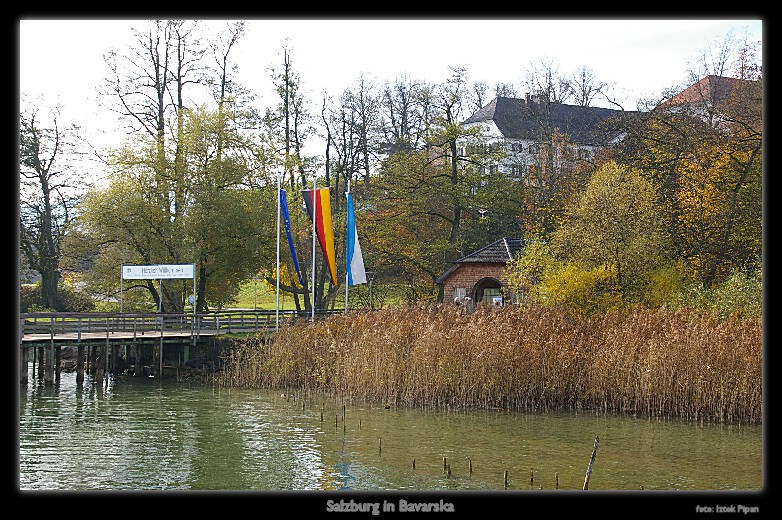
19 373 763 491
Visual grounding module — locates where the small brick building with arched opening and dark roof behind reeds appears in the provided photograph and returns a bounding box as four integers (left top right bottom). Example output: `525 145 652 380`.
437 238 523 307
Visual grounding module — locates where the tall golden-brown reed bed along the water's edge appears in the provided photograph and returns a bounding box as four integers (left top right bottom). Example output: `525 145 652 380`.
218 306 763 423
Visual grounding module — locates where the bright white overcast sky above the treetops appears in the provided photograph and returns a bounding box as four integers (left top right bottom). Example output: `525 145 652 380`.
19 17 763 155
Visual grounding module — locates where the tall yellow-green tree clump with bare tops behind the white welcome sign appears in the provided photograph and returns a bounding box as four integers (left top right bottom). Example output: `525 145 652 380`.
74 21 274 312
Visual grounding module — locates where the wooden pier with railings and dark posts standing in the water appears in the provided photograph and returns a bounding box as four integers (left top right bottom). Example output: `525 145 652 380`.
19 310 330 385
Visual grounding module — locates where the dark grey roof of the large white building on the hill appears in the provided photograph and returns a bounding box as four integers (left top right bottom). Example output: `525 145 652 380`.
463 97 626 145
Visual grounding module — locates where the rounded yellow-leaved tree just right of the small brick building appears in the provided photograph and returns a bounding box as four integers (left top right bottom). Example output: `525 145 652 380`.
509 162 670 313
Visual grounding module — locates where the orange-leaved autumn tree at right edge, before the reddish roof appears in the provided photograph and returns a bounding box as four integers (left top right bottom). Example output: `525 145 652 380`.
616 33 763 287
